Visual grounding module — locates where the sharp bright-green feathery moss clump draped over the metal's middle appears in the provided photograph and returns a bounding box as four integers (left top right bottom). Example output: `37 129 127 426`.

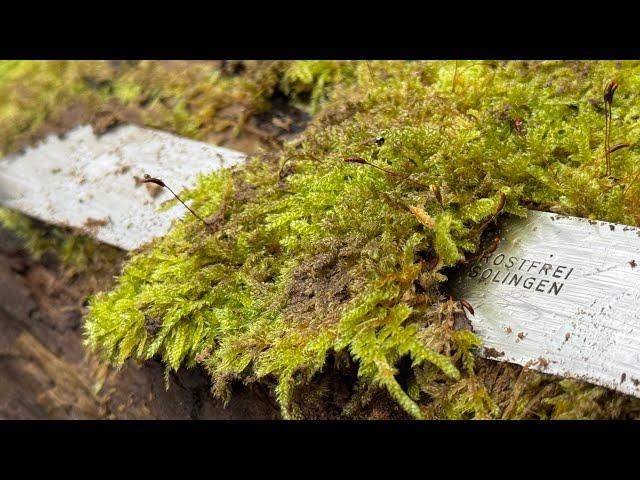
81 62 640 418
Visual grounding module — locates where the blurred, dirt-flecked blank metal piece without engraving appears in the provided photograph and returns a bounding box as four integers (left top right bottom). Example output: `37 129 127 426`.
0 125 245 250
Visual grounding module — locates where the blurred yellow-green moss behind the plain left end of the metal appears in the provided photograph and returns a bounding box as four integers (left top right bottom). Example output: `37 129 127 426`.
0 61 350 154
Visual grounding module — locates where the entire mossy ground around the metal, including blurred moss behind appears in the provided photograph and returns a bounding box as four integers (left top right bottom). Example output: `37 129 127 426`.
0 61 640 418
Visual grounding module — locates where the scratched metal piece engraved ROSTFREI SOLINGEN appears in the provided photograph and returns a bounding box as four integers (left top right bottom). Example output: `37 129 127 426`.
452 211 640 396
